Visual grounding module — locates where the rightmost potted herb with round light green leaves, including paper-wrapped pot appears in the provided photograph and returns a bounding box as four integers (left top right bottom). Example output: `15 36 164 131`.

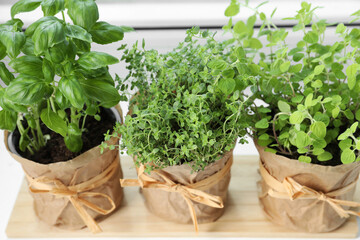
224 1 360 232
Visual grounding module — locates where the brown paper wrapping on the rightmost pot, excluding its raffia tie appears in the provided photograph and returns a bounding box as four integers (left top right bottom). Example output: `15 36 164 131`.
256 145 360 232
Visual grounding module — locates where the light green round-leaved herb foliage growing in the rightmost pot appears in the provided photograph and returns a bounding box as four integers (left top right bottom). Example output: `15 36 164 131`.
224 0 360 165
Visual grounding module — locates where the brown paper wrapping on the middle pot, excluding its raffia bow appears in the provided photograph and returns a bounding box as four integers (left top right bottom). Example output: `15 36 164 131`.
142 151 233 224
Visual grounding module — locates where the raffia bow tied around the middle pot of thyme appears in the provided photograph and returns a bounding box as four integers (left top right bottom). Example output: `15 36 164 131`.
120 156 233 233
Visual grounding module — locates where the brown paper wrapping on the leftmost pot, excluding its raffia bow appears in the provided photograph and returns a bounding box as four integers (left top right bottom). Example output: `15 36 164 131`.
5 106 123 230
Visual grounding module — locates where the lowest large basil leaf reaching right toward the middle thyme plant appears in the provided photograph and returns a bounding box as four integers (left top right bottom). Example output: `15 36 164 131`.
80 78 120 108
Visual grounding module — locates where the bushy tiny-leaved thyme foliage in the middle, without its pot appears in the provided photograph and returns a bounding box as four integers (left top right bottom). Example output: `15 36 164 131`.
103 28 248 171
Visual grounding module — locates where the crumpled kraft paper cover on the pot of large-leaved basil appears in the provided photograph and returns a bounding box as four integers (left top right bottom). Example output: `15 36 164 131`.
5 106 123 232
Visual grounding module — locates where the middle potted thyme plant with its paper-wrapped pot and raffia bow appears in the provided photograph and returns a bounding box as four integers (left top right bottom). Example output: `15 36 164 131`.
103 28 252 230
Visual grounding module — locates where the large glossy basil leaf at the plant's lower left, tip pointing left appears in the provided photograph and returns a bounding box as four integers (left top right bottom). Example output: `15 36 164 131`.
5 74 52 105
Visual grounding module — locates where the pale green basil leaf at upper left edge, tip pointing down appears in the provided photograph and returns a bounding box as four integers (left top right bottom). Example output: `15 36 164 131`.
0 31 25 59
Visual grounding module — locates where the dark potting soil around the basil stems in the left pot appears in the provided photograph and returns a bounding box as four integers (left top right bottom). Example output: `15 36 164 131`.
13 108 116 164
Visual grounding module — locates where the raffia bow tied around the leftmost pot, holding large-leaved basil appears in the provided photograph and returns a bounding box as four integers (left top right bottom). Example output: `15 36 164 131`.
25 157 119 233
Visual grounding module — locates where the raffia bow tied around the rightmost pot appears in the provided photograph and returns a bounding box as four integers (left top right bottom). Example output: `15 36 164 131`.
260 161 360 218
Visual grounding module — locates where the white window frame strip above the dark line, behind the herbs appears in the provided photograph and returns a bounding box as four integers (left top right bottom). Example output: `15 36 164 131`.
0 0 360 28
